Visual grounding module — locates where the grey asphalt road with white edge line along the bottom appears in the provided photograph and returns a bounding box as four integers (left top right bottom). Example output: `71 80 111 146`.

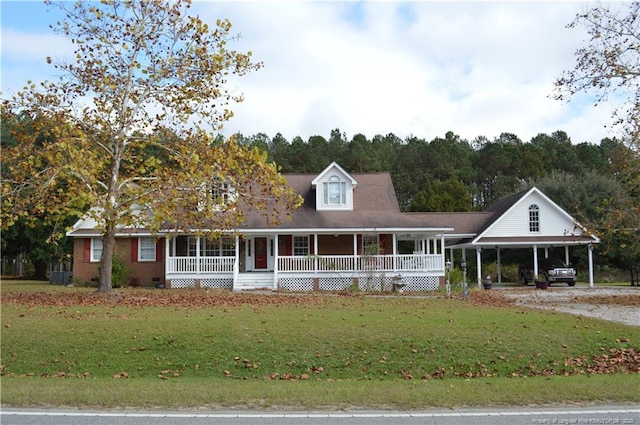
0 406 640 425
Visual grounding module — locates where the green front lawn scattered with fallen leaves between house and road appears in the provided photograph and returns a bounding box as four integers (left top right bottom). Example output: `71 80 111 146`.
0 282 640 408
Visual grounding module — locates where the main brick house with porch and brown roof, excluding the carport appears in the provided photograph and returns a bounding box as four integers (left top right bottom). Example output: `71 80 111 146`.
68 163 453 291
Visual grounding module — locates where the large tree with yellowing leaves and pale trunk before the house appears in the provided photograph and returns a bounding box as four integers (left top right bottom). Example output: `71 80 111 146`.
2 0 300 292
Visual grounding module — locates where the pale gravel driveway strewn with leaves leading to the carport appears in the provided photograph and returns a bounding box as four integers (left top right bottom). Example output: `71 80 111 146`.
503 287 640 326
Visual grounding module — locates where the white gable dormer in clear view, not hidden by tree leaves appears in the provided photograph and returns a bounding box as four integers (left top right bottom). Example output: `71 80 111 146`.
311 162 358 211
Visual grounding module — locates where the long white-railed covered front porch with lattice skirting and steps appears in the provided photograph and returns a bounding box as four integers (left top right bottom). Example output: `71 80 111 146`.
165 232 445 291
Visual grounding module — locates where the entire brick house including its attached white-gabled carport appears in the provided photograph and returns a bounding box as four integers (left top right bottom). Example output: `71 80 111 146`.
68 162 598 291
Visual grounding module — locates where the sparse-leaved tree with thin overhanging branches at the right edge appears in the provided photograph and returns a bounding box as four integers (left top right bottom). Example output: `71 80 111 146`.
555 1 640 282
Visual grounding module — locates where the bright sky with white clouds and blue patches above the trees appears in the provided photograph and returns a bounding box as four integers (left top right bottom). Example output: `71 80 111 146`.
0 0 610 143
